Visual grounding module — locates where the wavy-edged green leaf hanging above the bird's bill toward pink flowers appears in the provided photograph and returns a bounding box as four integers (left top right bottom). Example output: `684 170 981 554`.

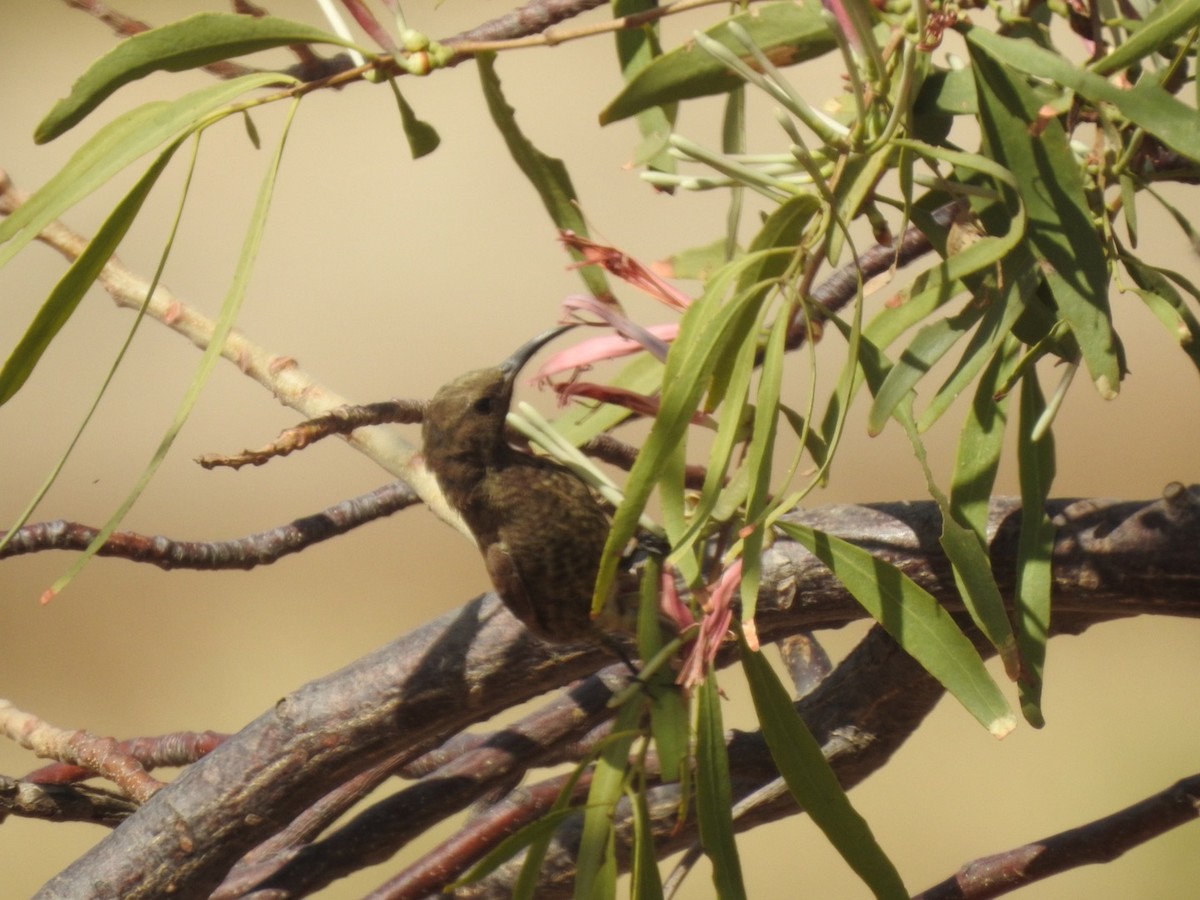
475 53 612 296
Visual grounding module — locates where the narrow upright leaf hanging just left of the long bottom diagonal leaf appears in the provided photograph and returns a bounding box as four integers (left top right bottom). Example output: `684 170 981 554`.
696 672 746 900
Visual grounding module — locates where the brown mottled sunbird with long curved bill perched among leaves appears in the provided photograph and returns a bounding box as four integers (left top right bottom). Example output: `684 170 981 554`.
421 325 636 668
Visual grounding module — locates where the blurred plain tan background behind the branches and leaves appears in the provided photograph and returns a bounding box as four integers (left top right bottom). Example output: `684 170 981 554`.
0 0 1200 900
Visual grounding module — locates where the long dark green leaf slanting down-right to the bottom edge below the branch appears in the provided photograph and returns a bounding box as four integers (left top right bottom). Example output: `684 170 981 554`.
742 638 908 900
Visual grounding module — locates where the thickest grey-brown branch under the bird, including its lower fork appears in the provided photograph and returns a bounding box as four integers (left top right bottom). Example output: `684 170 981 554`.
30 494 1200 898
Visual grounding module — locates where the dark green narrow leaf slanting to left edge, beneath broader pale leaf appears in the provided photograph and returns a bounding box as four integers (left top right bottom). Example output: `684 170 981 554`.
0 138 184 406
